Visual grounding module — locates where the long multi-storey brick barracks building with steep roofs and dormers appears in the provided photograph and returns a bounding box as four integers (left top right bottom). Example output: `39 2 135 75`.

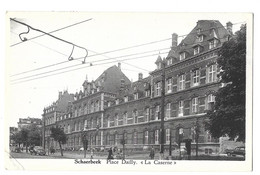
41 20 232 154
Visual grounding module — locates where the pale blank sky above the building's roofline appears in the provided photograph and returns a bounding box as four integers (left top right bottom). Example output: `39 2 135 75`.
5 12 248 127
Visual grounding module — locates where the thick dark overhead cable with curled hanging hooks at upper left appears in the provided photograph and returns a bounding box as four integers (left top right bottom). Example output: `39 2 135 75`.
10 18 88 63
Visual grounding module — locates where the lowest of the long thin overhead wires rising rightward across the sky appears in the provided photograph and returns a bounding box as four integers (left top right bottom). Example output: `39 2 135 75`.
11 52 168 85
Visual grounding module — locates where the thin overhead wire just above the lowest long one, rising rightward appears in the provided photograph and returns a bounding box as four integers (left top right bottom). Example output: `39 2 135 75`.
12 48 168 82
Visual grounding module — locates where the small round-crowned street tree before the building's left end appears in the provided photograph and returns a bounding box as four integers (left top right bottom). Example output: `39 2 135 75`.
51 127 67 156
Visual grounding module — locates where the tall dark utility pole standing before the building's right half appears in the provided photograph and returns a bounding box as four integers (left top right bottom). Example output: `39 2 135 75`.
160 60 165 159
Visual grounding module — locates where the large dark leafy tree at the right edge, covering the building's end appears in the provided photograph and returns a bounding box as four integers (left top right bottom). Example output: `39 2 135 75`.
207 25 246 141
